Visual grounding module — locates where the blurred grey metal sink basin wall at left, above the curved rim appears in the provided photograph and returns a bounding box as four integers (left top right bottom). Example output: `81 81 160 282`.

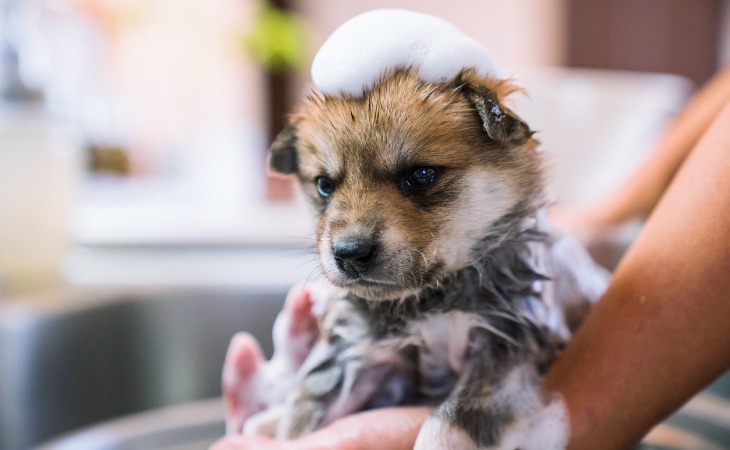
0 287 285 450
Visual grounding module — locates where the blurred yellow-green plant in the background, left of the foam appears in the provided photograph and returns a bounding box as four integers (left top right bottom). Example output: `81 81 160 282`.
243 0 309 73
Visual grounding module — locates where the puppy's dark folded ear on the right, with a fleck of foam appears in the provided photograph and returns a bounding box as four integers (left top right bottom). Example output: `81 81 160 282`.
464 84 532 145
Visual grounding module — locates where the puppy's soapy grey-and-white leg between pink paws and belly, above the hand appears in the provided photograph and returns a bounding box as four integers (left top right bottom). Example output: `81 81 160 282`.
277 299 415 439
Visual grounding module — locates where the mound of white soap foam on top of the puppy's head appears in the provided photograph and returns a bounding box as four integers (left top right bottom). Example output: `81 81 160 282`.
312 9 499 97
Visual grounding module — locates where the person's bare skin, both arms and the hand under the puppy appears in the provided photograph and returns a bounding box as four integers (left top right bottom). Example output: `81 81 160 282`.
213 70 730 450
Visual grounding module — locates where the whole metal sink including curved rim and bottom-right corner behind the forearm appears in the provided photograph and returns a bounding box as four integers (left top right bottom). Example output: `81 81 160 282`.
0 286 730 450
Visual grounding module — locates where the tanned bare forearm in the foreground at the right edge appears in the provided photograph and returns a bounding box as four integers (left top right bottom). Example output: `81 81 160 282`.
545 102 730 449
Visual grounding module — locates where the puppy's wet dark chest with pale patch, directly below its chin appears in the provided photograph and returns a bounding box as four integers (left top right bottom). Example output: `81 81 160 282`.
345 286 541 366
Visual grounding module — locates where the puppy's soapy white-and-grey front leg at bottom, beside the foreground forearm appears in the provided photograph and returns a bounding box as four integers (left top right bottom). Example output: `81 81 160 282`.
414 362 568 450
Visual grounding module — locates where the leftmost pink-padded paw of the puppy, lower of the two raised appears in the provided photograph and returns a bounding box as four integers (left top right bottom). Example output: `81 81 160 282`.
222 333 266 434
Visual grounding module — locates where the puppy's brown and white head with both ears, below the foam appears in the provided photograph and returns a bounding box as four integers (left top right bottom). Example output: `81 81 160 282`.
269 70 541 300
